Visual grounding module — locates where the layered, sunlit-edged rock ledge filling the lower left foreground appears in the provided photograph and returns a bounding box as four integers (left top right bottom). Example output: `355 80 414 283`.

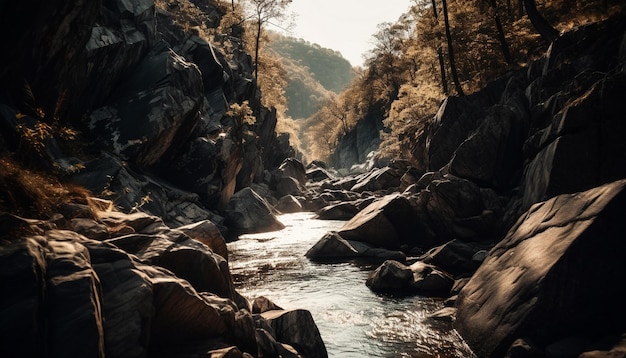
0 210 327 357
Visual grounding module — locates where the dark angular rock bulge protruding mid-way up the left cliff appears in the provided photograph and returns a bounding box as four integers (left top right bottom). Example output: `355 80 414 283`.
89 43 203 166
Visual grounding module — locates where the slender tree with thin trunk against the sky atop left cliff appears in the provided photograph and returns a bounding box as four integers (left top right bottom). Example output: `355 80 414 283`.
247 0 292 81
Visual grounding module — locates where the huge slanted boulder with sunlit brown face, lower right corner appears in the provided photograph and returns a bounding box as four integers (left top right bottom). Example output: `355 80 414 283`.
456 180 626 357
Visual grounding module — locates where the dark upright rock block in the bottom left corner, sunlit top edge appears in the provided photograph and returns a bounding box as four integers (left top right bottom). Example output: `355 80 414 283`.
0 231 105 357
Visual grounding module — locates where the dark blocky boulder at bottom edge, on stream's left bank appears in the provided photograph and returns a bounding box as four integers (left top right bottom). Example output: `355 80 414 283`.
261 310 328 358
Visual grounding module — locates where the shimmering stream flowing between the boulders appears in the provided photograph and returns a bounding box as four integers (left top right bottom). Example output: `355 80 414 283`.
228 213 474 358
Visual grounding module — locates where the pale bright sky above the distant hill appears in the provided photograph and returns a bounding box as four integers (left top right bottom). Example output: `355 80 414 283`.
276 0 411 66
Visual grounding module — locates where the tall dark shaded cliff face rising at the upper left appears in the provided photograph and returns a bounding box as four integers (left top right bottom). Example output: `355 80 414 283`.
0 0 294 232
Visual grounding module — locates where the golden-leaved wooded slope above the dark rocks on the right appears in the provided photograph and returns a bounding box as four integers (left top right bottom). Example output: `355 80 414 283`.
304 0 625 166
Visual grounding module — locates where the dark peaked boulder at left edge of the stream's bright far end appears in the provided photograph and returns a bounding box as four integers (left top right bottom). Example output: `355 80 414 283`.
225 188 285 233
